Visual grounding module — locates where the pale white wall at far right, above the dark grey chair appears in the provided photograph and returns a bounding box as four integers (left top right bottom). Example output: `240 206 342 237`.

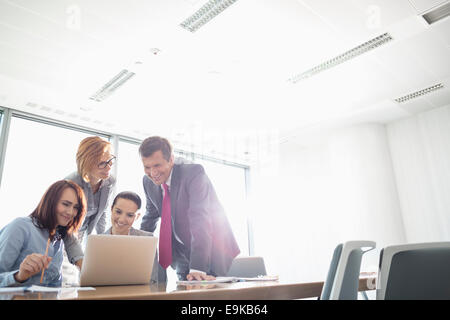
387 106 450 242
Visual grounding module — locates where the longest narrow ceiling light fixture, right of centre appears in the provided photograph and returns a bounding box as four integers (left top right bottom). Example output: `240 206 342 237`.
289 33 392 83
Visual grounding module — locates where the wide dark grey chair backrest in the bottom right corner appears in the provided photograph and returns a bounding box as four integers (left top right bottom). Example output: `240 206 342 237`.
377 242 450 300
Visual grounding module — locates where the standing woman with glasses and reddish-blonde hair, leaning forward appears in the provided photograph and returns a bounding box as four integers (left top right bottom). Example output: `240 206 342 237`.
64 136 116 269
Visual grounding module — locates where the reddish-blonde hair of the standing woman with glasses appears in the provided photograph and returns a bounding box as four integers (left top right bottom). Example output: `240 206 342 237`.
77 136 111 182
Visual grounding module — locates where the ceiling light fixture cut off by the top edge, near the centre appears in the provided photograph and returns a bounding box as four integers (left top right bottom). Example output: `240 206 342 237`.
180 0 237 32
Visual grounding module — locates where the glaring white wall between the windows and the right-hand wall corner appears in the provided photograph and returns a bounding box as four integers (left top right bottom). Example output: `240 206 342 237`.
252 125 406 281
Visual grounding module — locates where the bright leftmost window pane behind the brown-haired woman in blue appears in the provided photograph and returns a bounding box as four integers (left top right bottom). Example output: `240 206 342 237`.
0 116 103 228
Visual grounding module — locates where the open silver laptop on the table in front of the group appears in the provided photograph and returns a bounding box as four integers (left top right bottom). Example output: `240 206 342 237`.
80 234 158 286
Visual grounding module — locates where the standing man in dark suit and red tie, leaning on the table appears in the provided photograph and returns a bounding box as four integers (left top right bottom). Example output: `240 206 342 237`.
139 137 240 280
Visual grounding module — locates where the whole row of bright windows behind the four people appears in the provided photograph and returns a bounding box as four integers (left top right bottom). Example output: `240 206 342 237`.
0 110 249 283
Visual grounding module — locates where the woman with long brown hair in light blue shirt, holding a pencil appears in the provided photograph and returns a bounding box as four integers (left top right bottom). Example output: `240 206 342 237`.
0 180 86 287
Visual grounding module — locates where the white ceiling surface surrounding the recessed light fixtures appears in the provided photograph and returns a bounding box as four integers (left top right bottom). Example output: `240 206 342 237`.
0 0 450 161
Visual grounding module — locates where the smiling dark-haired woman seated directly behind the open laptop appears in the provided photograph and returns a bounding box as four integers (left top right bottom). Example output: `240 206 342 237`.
105 191 167 282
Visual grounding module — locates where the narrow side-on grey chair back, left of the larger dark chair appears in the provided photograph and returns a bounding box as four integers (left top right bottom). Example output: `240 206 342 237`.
320 240 376 300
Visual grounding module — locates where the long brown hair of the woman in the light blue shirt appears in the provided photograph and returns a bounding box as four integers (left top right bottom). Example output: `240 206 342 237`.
30 180 87 237
